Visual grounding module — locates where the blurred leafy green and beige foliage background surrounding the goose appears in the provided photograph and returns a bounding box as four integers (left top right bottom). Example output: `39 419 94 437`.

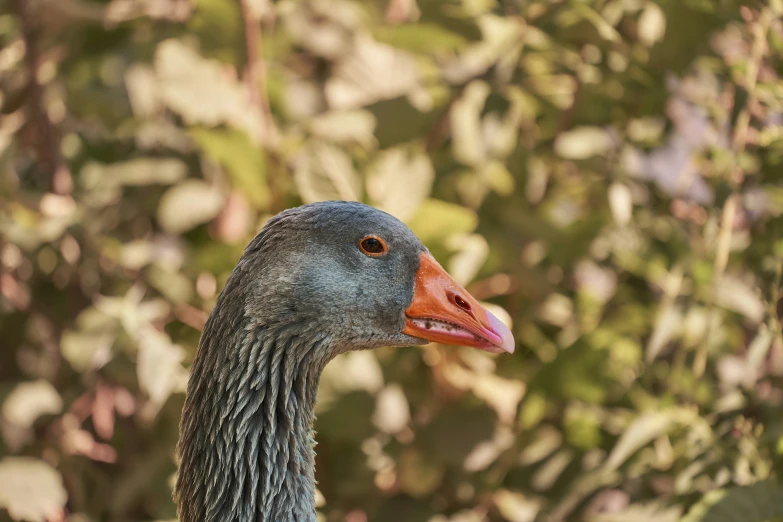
0 0 783 522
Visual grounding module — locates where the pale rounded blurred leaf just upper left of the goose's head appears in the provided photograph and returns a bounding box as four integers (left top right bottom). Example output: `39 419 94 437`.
158 179 225 234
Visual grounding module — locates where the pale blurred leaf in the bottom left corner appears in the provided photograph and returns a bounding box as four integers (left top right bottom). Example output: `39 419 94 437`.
0 457 68 522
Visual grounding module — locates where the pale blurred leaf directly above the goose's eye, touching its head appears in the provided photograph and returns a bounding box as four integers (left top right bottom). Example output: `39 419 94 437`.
367 147 435 221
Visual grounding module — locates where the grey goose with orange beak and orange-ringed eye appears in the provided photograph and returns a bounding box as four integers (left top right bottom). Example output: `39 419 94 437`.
175 201 514 522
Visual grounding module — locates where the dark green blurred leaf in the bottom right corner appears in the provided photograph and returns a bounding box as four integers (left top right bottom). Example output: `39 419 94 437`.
681 479 783 522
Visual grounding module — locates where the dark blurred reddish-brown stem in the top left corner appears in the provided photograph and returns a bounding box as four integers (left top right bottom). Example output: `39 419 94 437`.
16 0 73 194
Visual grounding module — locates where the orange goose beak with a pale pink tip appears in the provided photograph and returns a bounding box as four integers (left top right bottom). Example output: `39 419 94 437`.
403 252 514 353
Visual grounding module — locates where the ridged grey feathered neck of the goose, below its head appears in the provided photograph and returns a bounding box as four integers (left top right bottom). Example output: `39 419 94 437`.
175 292 334 522
